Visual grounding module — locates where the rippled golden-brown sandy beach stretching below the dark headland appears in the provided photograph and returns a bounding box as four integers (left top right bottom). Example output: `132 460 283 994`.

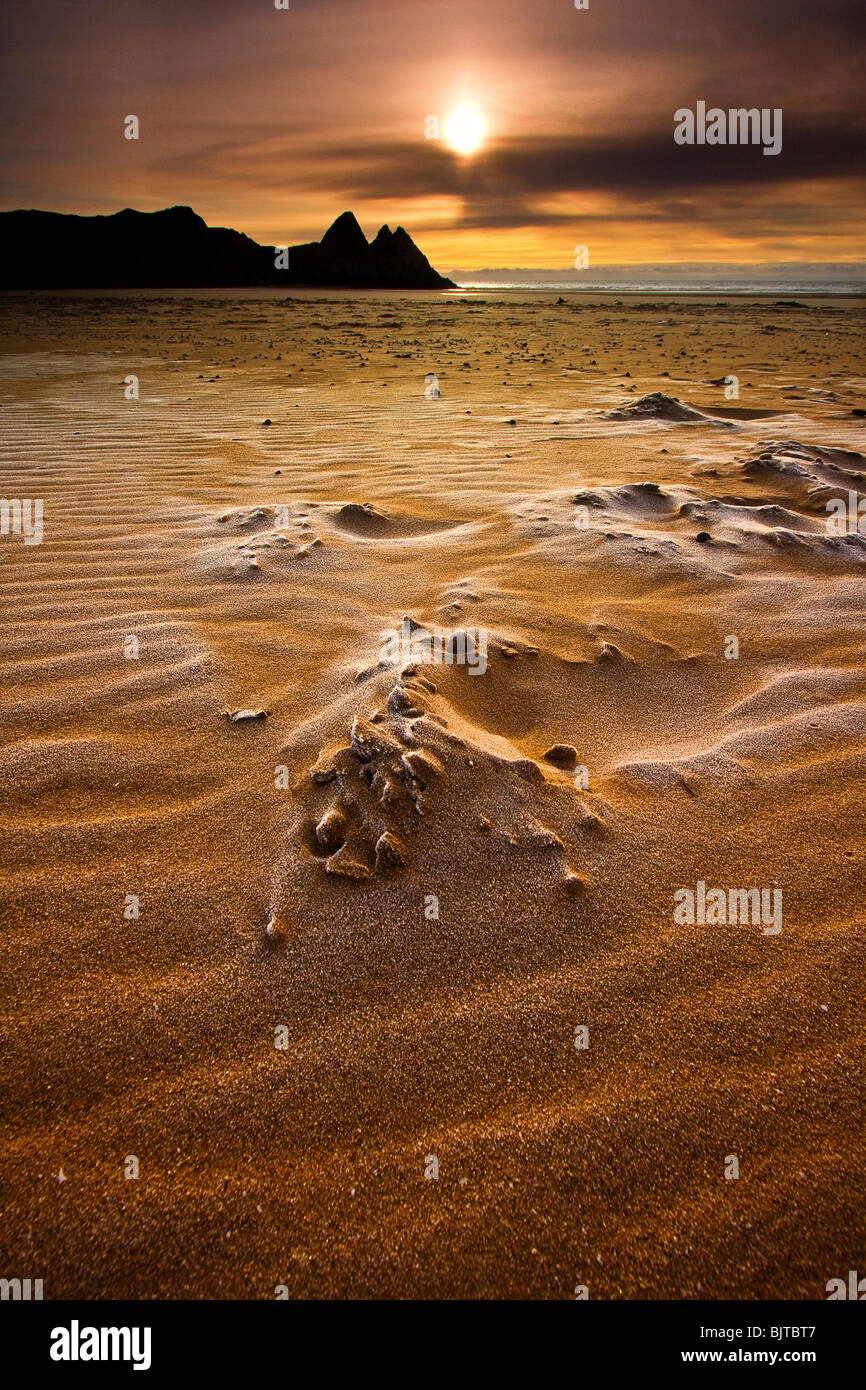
0 291 866 1301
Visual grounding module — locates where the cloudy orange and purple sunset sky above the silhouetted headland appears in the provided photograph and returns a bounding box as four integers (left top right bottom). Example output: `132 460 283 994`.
0 0 866 271
